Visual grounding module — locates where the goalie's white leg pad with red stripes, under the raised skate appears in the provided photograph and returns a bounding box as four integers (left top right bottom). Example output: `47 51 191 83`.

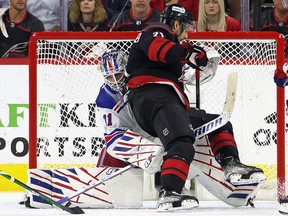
188 138 263 207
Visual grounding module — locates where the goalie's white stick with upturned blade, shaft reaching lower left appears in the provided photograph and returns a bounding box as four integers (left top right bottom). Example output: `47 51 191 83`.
57 72 237 206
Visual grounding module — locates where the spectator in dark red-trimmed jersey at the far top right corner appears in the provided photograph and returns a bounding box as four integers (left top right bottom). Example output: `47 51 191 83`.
255 0 288 57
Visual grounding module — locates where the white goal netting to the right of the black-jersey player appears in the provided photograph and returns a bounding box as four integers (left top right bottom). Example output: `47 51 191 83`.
186 40 277 198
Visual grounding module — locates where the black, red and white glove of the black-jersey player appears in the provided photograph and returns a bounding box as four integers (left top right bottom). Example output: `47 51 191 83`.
181 42 208 70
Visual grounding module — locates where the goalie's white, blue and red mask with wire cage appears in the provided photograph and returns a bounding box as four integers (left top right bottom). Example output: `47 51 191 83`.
100 49 128 92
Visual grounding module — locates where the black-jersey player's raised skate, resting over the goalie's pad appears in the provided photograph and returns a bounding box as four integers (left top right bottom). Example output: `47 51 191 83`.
222 157 266 186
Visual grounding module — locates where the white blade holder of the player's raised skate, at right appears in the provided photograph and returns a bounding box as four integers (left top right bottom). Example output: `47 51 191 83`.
227 172 266 186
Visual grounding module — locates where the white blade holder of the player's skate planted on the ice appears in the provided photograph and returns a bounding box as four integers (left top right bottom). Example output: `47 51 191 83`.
157 200 199 212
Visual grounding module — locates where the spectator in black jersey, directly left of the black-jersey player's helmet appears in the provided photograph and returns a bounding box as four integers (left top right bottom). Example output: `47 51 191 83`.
107 0 160 31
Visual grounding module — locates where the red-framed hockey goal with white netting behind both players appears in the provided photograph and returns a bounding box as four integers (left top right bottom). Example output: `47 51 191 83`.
29 32 286 200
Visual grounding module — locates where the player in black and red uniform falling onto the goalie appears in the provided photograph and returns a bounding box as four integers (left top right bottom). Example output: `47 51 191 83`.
127 4 265 211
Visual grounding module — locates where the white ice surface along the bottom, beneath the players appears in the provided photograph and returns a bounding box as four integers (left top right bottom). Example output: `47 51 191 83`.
0 193 281 216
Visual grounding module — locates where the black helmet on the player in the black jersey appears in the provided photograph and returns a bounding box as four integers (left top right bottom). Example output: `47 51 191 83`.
160 4 195 30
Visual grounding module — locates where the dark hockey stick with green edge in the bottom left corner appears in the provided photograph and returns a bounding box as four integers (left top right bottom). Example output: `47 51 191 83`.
0 170 85 214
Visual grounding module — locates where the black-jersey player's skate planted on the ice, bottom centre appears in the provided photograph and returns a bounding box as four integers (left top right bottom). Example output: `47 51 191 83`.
157 189 199 212
